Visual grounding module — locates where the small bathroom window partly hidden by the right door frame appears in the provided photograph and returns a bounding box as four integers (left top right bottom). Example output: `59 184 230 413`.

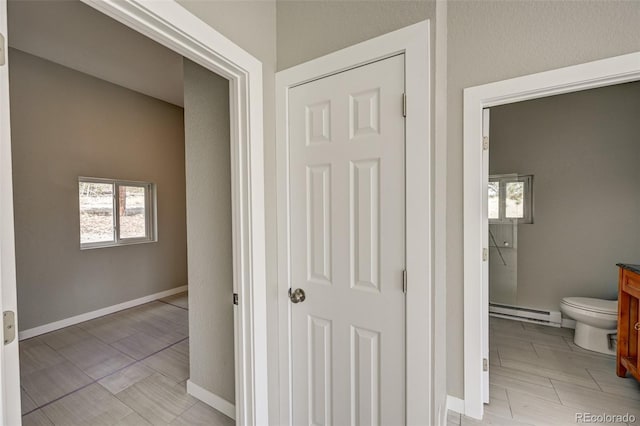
488 175 533 223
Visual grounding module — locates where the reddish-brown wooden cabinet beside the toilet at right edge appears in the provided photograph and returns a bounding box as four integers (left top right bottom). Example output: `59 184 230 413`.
616 264 640 381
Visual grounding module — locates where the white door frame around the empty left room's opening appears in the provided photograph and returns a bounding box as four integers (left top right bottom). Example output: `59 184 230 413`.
0 0 269 425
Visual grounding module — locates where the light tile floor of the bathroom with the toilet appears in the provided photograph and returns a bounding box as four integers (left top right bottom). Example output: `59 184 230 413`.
448 318 640 426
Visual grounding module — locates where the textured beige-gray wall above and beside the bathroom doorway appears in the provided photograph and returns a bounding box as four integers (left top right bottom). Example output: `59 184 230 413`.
447 0 640 397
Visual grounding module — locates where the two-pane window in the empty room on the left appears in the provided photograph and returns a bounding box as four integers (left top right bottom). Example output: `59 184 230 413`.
78 177 157 249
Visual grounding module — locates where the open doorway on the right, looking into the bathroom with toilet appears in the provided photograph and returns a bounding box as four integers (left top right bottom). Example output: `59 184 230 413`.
478 82 640 424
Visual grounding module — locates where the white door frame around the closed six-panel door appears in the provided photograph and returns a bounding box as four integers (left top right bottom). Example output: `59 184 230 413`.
276 21 433 425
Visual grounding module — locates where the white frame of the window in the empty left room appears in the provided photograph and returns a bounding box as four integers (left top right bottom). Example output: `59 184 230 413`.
78 176 158 250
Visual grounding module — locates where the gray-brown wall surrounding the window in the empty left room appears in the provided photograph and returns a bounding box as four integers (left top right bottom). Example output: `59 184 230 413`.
9 49 187 330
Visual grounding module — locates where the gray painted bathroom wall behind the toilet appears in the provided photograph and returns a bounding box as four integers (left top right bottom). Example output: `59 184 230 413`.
489 83 640 311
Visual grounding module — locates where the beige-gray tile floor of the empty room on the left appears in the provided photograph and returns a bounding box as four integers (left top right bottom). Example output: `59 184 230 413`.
20 293 235 426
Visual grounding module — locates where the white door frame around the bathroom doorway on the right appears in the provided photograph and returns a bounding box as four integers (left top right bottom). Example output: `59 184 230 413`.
463 52 640 419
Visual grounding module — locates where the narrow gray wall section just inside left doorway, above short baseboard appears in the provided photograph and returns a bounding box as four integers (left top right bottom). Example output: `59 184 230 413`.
184 59 235 403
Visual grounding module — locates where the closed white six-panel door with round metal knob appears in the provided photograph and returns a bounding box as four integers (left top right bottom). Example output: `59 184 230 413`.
288 55 406 425
